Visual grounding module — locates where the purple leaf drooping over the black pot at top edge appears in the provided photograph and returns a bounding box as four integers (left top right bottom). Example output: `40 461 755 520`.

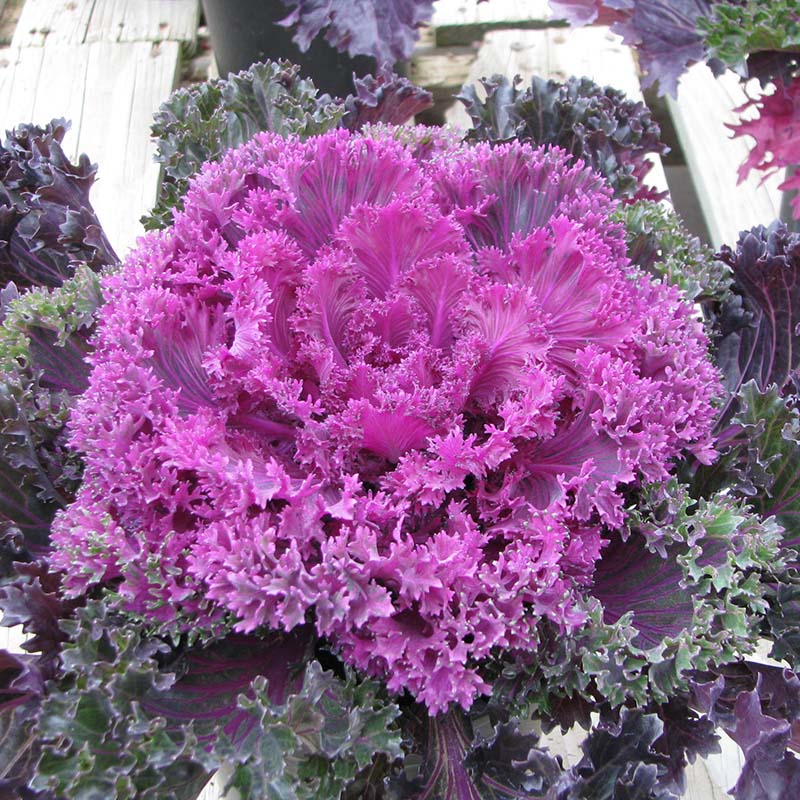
281 0 433 64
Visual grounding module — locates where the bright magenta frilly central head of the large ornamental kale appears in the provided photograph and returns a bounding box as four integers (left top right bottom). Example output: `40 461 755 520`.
53 127 719 713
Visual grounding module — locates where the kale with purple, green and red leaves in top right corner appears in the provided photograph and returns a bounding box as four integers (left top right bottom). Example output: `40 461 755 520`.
550 0 800 219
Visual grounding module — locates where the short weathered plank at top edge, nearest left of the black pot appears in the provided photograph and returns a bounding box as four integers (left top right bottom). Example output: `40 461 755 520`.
86 0 200 42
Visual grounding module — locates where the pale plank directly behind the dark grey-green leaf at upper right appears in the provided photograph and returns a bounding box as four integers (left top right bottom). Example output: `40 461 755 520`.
447 26 668 196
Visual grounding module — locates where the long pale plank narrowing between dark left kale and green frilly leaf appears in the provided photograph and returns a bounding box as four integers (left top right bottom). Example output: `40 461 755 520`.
78 42 180 255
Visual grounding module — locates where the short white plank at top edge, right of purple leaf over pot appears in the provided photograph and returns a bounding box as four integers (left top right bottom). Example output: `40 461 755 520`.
431 0 564 47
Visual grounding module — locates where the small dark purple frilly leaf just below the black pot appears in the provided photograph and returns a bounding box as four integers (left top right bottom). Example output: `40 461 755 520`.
342 68 433 131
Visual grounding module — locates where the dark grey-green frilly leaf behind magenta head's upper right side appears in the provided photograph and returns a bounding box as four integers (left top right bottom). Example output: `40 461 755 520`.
459 75 668 200
